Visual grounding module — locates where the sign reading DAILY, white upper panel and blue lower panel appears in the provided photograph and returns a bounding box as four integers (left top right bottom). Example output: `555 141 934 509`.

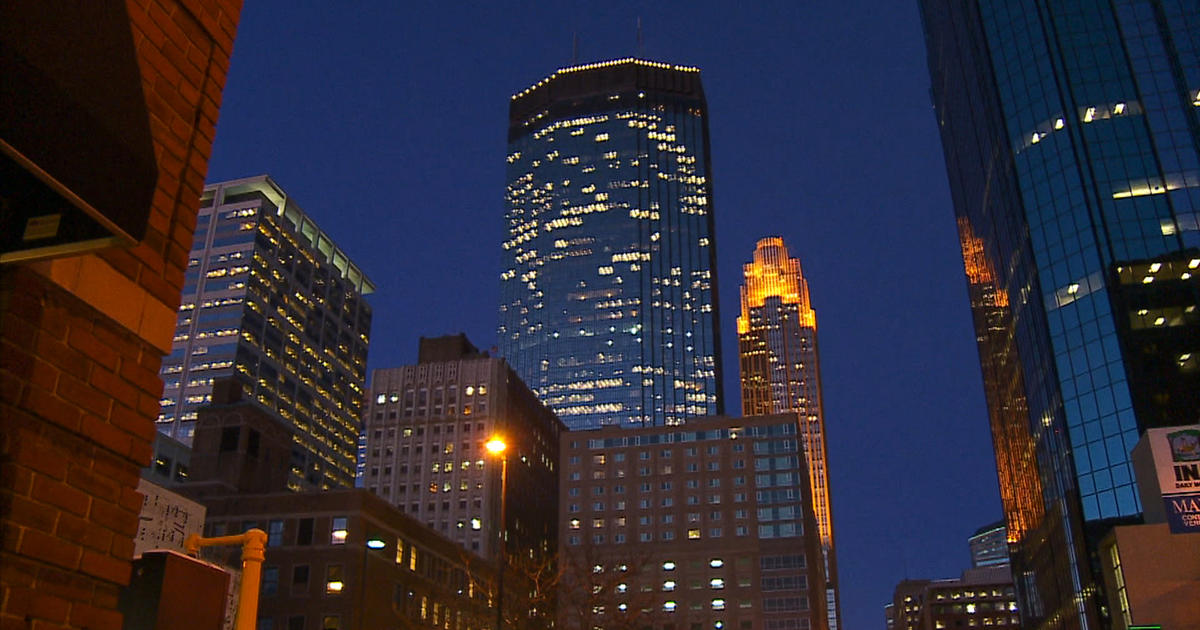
1146 425 1200 534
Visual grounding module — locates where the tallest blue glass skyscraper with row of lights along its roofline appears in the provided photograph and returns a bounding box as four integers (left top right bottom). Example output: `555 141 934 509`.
499 59 722 430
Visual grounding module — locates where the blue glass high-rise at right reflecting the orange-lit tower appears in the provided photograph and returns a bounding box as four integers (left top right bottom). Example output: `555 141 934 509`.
920 0 1200 629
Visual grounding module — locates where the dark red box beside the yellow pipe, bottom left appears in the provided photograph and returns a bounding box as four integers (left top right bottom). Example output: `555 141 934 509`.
120 551 229 630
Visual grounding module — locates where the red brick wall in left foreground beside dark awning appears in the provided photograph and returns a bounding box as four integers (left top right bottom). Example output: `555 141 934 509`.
0 0 241 630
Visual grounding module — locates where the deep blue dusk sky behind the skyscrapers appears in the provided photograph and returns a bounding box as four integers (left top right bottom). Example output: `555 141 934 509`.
209 0 1001 630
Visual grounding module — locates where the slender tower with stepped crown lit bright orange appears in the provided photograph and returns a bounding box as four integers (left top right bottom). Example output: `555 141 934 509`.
738 236 839 630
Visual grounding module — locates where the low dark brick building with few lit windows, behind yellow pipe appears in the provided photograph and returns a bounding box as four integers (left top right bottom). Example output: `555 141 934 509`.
201 486 496 630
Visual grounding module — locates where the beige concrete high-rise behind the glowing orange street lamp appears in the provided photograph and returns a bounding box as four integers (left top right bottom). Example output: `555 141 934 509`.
362 335 565 558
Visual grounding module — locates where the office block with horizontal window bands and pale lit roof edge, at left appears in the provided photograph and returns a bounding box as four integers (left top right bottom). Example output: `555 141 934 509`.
158 175 374 490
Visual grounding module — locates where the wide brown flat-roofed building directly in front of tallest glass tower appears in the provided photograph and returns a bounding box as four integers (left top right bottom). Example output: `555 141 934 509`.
558 413 827 630
